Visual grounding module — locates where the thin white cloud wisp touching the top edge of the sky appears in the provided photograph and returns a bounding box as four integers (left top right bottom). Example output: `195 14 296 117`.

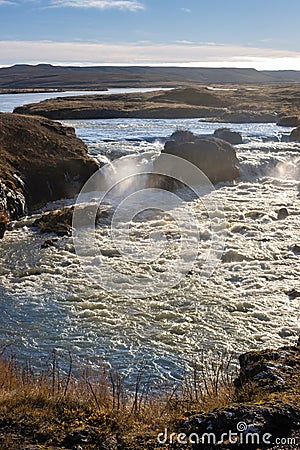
50 0 145 11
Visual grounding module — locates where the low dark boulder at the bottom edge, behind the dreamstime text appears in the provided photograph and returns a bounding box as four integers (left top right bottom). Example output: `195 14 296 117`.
183 402 300 450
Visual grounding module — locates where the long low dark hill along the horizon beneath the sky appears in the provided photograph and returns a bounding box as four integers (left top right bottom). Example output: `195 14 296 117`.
0 64 300 89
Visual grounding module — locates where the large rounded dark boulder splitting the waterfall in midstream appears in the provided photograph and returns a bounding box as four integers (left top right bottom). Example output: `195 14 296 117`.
162 131 239 183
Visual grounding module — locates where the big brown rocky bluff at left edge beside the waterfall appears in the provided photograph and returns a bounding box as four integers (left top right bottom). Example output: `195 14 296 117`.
0 113 98 232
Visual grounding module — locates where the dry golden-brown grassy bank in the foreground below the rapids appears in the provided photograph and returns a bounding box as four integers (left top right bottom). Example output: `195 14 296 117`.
0 347 300 450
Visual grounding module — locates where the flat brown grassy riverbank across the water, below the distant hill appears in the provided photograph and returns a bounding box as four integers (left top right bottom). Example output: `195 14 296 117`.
14 84 300 123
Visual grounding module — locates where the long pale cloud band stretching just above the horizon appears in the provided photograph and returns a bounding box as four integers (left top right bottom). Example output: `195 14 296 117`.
0 41 300 70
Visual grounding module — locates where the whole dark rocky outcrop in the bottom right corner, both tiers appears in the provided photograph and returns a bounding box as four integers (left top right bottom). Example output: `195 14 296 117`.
180 340 300 450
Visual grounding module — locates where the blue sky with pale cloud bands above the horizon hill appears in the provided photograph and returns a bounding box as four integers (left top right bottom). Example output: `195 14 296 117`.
0 0 300 70
